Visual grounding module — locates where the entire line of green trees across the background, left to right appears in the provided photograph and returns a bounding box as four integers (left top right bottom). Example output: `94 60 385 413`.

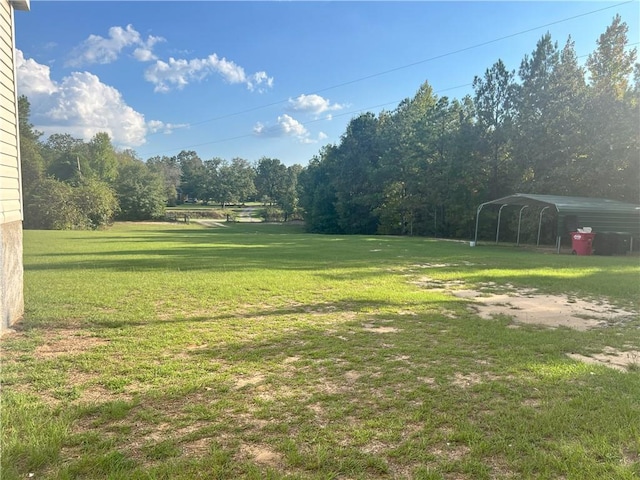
19 16 640 238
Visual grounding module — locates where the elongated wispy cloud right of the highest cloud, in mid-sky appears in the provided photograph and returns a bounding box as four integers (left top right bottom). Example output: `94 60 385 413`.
144 53 273 93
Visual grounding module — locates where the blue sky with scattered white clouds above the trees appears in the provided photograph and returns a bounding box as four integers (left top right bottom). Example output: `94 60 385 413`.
15 0 640 166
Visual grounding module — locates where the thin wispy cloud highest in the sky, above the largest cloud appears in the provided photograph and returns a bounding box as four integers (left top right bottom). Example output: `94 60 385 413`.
66 25 164 67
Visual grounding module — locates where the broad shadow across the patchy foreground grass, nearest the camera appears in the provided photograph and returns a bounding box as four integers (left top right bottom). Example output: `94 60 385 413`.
7 300 639 478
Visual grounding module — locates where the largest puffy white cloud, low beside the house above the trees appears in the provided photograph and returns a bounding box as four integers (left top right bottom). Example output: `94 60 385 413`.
16 50 148 147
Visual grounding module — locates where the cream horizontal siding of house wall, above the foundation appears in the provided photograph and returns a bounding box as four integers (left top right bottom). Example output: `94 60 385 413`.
0 0 22 224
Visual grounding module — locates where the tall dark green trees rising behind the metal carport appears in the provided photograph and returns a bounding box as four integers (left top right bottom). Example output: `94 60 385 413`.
300 16 640 238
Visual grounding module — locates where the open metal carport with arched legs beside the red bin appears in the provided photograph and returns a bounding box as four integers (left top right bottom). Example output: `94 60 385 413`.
474 193 640 253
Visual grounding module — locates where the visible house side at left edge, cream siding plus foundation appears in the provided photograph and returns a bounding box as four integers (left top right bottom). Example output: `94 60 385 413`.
0 0 29 333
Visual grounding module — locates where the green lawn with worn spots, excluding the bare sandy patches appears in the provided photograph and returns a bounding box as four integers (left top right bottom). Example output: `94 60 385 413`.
2 224 640 480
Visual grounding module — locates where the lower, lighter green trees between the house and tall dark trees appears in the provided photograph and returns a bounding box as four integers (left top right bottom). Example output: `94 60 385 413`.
18 96 302 229
